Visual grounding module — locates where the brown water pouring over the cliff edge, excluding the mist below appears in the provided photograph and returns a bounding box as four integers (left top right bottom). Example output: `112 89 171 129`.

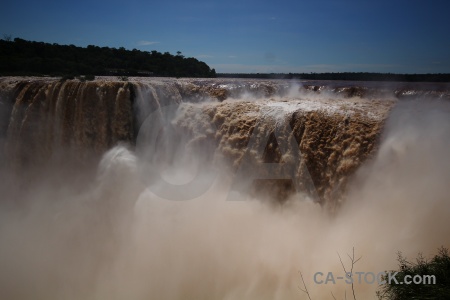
0 78 395 206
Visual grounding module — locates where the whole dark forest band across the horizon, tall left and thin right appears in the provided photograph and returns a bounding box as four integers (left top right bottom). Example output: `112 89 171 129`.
0 37 450 82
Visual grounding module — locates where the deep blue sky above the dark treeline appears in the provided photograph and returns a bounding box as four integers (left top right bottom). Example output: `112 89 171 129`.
0 0 450 73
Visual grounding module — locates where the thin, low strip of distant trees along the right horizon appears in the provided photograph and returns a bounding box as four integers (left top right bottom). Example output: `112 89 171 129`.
217 72 450 82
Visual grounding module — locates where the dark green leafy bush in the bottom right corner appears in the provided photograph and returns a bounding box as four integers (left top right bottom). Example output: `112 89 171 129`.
377 247 450 300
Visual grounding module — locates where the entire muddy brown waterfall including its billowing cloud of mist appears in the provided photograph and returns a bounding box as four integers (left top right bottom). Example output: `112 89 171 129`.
0 79 450 299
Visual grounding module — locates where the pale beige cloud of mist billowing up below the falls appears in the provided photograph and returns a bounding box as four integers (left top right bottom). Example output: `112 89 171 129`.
0 92 450 300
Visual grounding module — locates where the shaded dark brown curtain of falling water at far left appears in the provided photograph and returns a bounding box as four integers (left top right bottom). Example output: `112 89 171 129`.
3 80 134 167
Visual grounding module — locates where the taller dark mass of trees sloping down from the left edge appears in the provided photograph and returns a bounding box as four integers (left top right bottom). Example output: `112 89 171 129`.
0 38 216 77
